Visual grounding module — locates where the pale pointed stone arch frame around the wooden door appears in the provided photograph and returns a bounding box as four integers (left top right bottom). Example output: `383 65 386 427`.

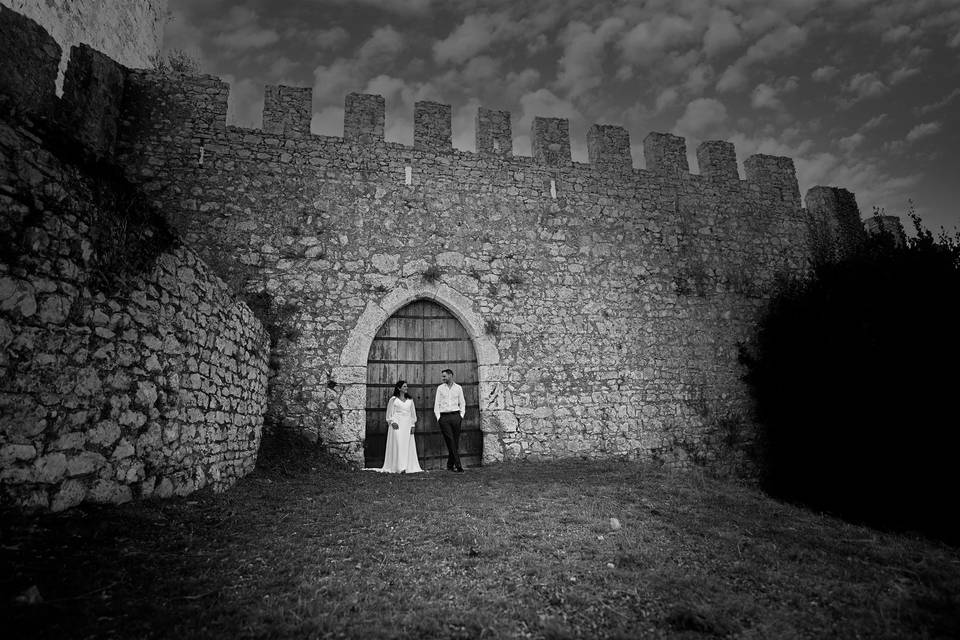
325 282 517 465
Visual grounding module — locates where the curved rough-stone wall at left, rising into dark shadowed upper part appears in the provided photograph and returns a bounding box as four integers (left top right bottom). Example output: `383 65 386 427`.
0 9 269 510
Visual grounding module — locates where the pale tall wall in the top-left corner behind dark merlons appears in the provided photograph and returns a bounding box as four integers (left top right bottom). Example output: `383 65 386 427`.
0 0 167 82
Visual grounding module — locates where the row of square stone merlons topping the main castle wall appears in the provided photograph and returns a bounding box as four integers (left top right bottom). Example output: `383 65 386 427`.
179 81 800 191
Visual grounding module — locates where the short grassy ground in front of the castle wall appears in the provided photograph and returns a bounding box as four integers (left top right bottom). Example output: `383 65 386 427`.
0 462 960 638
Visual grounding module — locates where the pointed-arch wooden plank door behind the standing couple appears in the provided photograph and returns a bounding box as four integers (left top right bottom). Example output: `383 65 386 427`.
364 300 483 469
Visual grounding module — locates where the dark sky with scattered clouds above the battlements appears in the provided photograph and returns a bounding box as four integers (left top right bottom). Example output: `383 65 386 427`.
165 0 960 230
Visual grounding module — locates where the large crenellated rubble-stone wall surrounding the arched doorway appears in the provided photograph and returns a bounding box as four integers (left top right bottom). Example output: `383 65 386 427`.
110 72 848 480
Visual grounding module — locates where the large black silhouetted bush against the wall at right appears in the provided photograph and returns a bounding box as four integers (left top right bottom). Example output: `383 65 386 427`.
741 212 960 541
